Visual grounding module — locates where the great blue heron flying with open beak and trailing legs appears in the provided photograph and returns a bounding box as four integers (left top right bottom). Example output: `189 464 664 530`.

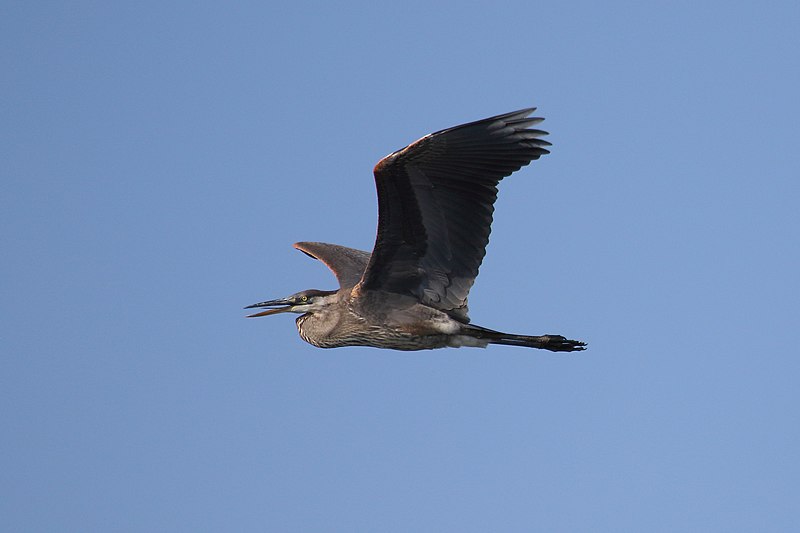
245 108 586 352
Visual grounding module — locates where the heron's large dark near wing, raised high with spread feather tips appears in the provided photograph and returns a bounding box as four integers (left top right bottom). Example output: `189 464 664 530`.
359 108 550 322
